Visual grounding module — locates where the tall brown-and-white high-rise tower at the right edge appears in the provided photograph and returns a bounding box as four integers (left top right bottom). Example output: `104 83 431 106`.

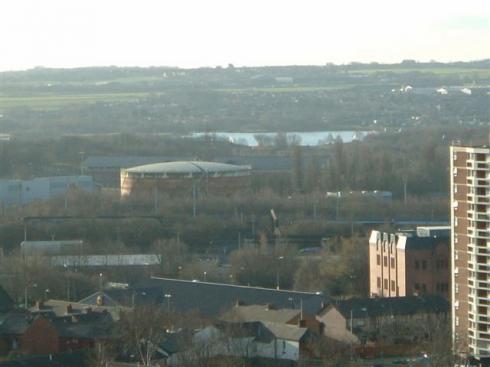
450 146 490 361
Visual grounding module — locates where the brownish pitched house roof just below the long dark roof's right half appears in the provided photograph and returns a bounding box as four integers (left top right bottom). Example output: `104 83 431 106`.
221 305 301 324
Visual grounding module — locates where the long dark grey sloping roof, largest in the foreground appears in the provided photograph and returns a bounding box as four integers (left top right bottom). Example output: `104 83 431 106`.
79 277 327 317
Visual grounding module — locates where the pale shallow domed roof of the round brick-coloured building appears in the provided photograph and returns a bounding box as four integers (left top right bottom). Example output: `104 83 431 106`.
126 161 251 173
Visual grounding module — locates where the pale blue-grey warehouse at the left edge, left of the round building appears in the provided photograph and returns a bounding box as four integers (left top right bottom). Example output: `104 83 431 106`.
0 176 96 207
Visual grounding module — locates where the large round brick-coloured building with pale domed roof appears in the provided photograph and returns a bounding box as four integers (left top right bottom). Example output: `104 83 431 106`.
121 161 251 196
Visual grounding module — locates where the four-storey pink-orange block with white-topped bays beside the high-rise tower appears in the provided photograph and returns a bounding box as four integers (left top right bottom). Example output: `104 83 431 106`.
369 226 450 299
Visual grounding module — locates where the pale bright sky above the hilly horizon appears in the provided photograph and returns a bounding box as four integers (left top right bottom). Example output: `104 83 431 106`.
0 0 490 71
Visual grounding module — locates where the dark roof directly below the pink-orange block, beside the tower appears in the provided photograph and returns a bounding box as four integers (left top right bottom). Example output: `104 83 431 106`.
333 295 449 318
